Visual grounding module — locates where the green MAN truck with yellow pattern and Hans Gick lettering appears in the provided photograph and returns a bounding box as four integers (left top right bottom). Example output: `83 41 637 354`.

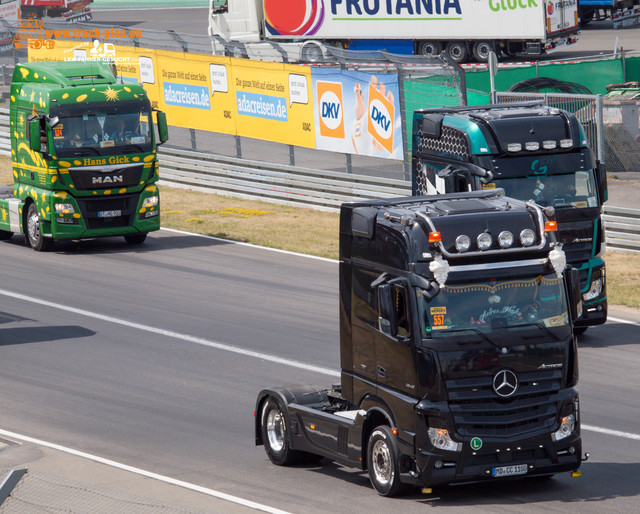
0 61 167 251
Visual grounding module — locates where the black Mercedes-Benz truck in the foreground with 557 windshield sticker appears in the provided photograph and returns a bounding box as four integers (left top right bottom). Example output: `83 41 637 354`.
255 189 582 496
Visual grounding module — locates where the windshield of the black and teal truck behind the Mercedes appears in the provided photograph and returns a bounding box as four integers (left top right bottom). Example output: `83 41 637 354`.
493 170 598 209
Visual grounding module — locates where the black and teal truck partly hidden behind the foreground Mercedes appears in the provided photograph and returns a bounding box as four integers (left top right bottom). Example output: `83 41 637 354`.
412 102 607 333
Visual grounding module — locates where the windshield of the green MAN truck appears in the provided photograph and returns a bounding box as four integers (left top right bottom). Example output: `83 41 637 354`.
53 111 151 157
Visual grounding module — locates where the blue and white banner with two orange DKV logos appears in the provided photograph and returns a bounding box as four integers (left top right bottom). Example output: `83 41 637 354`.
311 68 402 160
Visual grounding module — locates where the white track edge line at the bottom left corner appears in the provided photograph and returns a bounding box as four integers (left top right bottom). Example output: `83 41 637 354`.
0 429 286 514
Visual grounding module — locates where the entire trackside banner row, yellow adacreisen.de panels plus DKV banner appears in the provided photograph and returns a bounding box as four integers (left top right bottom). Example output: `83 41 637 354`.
29 40 403 160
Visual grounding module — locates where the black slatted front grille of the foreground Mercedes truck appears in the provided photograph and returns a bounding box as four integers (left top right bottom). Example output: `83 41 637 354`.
446 369 562 437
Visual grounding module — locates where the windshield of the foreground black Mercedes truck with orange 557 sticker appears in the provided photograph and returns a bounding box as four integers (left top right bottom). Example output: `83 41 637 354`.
418 274 569 339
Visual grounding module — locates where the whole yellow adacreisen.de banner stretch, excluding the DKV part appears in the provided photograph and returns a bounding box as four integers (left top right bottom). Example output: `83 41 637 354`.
29 40 316 148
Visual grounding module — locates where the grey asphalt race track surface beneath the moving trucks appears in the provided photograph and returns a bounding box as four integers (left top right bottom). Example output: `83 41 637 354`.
0 230 640 513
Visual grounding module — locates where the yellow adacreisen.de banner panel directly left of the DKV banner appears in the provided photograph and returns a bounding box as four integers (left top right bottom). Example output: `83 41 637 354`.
231 59 315 148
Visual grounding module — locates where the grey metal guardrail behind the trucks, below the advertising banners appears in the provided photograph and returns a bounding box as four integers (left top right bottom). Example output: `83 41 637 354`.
0 108 640 253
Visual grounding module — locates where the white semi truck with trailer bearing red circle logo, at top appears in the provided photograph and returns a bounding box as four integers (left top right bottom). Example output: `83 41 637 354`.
209 0 579 63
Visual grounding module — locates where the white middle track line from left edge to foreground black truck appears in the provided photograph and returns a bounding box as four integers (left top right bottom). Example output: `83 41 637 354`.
0 289 340 377
